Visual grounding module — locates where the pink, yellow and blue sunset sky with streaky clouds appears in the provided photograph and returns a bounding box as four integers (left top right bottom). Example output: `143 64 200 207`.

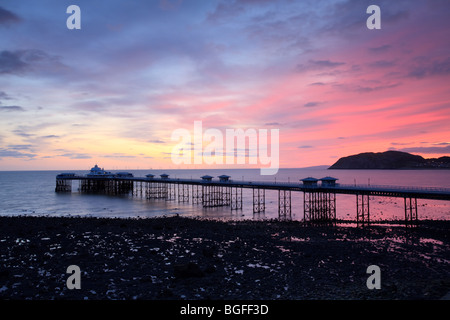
0 0 450 170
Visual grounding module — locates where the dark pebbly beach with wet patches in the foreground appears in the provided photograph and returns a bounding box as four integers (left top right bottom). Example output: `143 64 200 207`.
0 216 450 300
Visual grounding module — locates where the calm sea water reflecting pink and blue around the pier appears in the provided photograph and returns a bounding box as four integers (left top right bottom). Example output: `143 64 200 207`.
0 168 450 220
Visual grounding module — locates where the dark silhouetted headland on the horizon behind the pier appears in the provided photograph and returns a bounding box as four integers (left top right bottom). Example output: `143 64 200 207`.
328 151 450 169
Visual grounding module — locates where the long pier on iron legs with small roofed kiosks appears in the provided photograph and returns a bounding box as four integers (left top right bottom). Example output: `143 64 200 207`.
55 165 450 227
